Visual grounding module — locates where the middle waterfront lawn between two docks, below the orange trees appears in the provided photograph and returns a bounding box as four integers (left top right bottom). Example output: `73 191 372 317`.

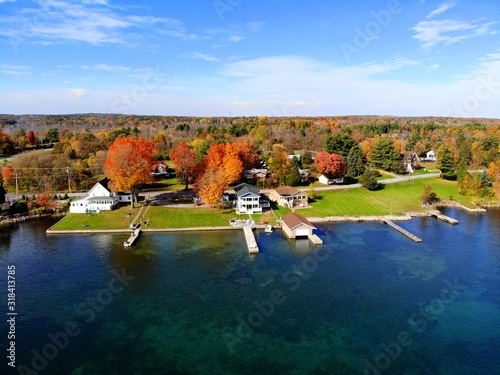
144 206 236 228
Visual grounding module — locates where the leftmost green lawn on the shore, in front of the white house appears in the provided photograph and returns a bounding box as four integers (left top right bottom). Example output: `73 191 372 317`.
53 206 140 230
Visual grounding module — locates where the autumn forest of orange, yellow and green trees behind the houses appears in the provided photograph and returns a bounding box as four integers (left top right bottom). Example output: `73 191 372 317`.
0 114 500 209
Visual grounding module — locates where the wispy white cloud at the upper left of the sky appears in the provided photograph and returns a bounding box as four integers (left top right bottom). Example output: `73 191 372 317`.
0 0 197 45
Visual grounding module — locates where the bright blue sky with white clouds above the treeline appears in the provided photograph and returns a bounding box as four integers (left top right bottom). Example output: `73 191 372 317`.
0 0 500 118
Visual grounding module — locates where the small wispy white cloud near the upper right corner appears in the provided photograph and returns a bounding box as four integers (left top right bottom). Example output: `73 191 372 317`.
410 19 495 49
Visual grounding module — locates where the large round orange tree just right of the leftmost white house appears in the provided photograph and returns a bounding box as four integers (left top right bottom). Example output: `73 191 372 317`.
104 137 157 208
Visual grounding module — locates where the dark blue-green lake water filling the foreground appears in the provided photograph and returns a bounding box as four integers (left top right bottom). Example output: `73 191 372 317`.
0 209 500 375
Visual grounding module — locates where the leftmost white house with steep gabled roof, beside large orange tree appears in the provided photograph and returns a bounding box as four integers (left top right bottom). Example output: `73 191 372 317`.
69 178 132 214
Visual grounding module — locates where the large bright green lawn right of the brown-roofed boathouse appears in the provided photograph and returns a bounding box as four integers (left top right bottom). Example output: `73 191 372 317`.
297 178 474 217
